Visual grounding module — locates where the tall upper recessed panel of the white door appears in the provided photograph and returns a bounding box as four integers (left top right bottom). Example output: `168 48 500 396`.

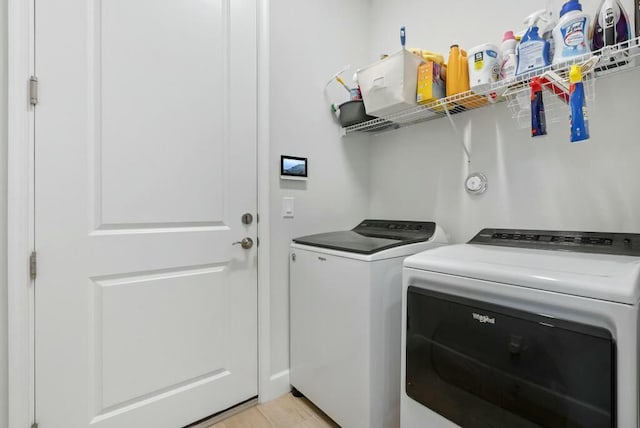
100 0 230 227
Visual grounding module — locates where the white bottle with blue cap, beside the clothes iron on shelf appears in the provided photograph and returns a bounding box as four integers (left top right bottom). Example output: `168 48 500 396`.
553 0 591 64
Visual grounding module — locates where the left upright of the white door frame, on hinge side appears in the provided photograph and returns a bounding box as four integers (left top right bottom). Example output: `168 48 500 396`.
7 0 34 427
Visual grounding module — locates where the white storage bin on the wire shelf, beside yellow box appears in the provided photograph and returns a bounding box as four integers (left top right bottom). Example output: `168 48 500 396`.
358 49 424 117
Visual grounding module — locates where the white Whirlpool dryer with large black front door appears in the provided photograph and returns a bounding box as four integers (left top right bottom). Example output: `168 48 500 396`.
401 229 640 428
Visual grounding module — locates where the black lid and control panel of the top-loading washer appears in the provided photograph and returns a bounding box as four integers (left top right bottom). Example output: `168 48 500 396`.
293 220 436 254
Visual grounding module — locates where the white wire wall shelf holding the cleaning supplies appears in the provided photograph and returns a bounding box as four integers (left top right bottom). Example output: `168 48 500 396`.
343 37 640 135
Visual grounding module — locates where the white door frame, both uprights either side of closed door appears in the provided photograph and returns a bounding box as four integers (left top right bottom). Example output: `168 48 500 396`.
7 0 276 428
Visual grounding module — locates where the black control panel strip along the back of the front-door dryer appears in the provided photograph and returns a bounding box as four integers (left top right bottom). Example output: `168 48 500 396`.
469 229 640 256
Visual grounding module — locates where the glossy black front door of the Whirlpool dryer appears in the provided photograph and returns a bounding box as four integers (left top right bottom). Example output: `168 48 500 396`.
405 286 616 428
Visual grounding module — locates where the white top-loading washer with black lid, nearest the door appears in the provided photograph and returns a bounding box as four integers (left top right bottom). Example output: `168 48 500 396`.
290 220 447 428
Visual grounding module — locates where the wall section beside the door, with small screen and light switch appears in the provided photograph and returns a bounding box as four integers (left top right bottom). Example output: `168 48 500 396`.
270 0 370 394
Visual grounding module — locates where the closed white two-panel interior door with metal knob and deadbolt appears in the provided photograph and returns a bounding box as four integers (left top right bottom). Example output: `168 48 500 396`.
35 0 257 428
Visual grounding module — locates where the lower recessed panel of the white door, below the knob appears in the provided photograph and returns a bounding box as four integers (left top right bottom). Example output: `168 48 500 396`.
99 266 228 408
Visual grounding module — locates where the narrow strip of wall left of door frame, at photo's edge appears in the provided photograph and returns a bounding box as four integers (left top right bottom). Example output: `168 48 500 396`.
0 0 8 428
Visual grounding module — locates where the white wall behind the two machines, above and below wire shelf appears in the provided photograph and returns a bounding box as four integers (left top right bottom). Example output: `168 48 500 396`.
371 0 640 242
